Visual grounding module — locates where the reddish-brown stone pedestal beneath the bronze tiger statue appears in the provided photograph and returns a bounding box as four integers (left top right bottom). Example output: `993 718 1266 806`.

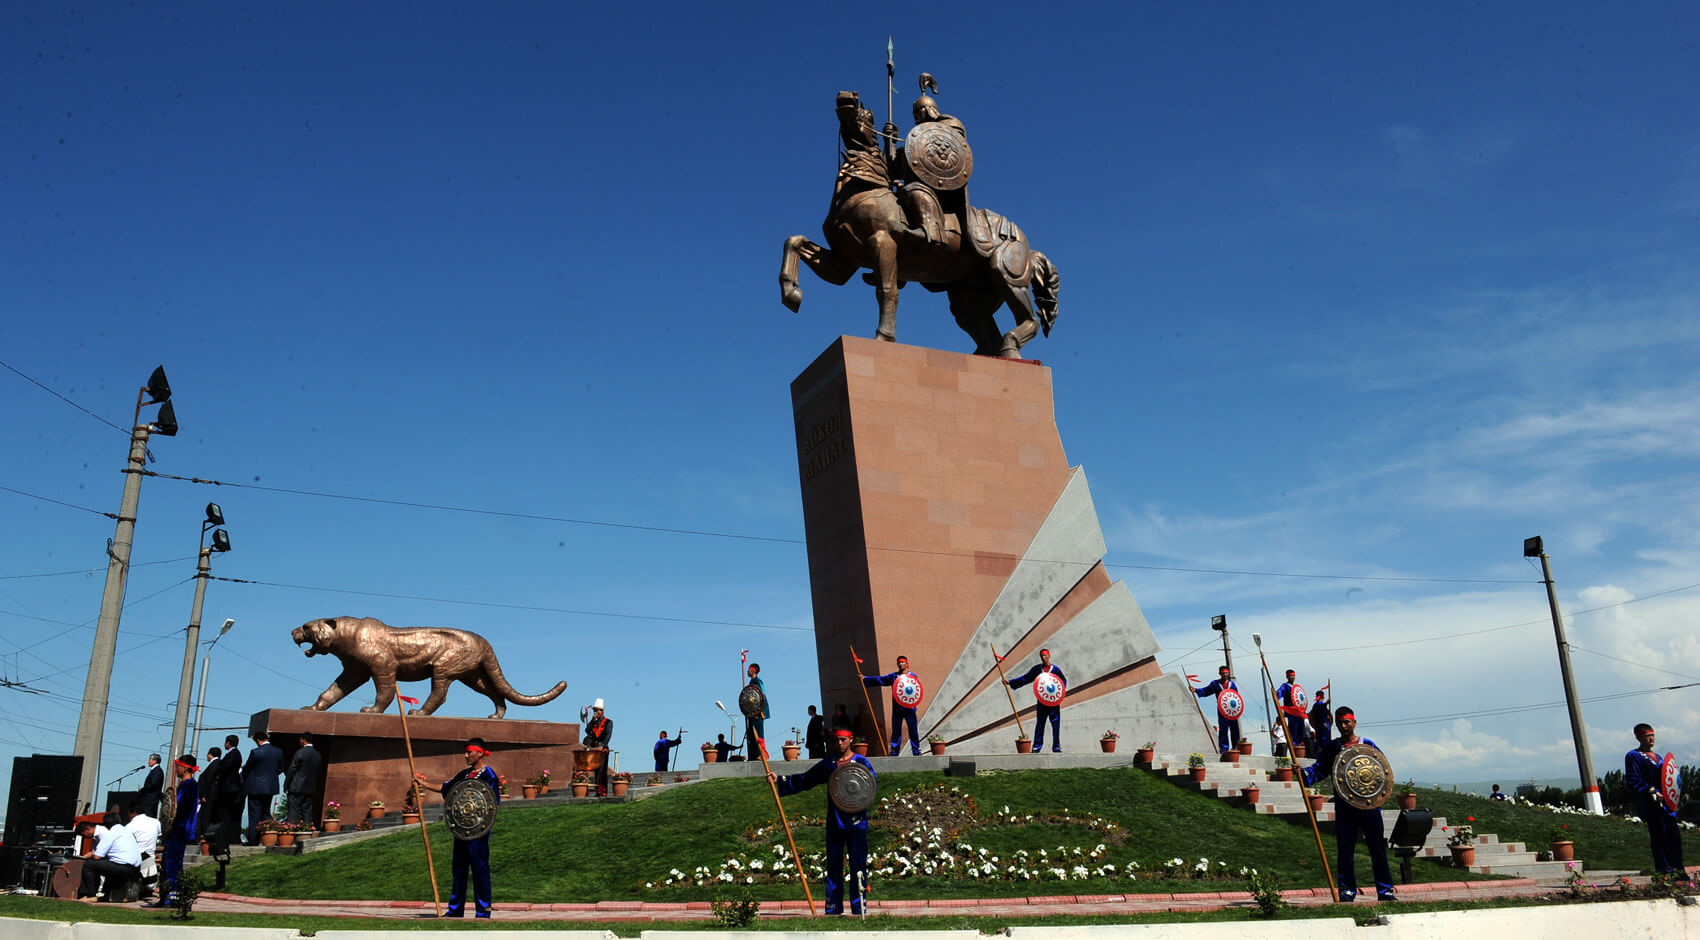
248 709 583 812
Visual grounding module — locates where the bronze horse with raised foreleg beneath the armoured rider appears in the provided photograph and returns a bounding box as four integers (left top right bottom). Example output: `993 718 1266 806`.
779 92 1061 359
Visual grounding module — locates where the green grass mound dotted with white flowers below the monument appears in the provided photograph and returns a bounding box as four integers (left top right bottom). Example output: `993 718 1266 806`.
215 770 1686 903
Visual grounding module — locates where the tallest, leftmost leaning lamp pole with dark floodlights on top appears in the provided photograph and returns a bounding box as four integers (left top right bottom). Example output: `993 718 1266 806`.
71 365 177 806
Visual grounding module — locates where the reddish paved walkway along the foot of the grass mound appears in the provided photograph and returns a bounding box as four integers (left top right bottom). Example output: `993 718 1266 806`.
196 877 1584 923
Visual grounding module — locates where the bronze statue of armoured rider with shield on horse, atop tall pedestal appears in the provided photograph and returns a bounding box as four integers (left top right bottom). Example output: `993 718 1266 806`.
779 73 1061 359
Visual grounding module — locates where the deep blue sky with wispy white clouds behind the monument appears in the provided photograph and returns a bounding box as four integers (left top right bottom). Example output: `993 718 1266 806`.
0 3 1700 805
